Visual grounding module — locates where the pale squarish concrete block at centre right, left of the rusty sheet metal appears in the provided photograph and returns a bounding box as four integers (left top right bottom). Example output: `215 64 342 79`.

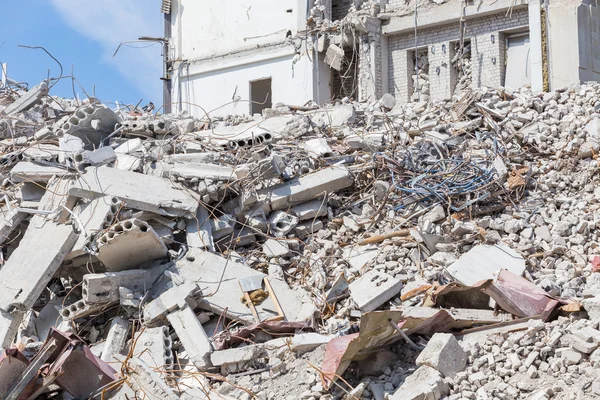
349 271 402 312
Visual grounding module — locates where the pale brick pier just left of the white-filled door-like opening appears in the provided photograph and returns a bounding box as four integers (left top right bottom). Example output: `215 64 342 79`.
471 31 506 88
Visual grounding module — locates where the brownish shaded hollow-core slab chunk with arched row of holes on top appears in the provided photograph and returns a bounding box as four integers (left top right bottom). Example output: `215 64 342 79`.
97 219 168 272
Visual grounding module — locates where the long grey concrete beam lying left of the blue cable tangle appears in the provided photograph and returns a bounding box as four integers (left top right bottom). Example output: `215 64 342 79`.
232 167 354 216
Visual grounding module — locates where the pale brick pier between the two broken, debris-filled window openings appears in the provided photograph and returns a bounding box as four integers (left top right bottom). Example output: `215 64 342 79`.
428 42 456 100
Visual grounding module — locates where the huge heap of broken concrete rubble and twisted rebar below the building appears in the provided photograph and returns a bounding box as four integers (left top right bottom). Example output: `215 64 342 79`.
0 76 600 400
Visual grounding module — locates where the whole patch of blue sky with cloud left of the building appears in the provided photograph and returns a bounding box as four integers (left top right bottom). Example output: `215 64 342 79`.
0 0 163 106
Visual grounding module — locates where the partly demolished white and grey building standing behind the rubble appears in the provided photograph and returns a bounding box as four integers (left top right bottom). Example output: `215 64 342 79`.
162 0 600 118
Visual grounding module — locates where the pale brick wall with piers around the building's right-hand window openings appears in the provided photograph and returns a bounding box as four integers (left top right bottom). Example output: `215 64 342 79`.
388 8 529 101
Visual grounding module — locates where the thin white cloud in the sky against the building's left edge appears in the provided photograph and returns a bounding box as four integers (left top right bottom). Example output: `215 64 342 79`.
50 0 163 103
